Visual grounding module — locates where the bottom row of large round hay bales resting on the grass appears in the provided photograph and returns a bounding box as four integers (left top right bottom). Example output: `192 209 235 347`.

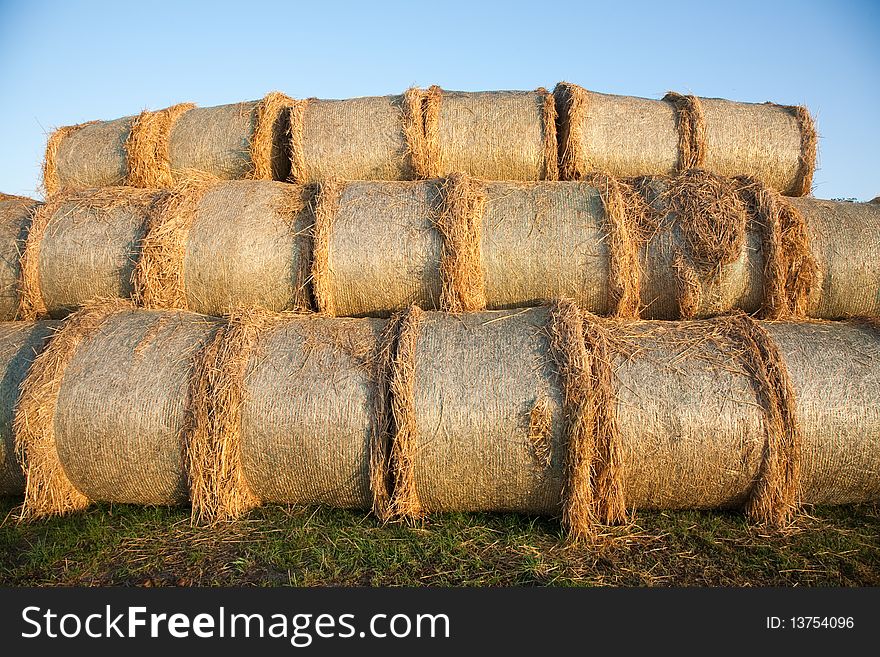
0 301 880 536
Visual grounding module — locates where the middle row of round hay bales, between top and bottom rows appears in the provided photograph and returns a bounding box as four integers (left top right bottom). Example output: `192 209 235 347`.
6 171 880 320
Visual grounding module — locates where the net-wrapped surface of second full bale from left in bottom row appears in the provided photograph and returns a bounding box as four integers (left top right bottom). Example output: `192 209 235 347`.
240 317 385 509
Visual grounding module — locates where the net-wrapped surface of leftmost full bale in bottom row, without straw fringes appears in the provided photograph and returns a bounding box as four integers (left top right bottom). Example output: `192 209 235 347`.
52 310 221 504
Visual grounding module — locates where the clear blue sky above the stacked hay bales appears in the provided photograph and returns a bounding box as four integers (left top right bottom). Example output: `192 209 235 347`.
0 0 880 200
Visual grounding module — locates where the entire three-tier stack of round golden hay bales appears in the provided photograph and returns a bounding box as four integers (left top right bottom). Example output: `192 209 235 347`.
0 83 880 537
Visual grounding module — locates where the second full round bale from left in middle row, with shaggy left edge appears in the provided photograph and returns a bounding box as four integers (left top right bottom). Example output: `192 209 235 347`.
134 180 311 315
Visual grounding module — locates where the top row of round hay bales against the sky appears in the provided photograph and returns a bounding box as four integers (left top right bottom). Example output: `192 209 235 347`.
44 82 816 196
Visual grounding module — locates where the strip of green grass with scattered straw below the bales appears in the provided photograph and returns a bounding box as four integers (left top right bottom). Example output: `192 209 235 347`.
0 498 880 586
